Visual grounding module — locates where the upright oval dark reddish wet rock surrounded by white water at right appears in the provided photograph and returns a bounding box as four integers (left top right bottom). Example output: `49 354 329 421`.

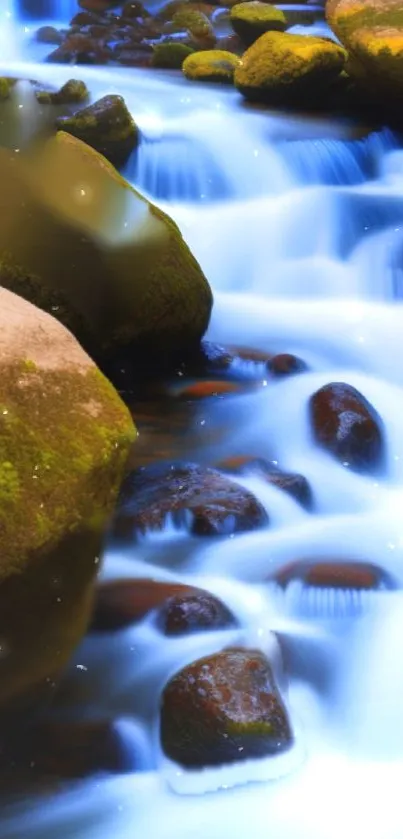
309 382 384 471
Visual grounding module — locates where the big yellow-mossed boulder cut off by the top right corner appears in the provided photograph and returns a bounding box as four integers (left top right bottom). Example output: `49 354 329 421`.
326 0 403 104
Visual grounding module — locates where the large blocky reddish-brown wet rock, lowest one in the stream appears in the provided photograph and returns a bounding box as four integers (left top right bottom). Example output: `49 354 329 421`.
161 649 293 769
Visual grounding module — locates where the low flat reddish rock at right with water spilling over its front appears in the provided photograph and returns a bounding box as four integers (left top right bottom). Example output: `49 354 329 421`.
274 559 395 591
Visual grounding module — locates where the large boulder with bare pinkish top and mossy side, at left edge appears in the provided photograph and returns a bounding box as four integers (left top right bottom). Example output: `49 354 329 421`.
0 288 135 722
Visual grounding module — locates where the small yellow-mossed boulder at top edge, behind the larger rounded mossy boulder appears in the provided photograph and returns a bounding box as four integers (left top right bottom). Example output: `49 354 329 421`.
230 0 287 47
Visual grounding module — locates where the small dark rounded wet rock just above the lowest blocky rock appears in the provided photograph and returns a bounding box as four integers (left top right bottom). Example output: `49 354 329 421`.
157 589 237 635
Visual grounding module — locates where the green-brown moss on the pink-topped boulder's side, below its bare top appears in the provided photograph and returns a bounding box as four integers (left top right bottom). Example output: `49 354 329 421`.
0 365 136 578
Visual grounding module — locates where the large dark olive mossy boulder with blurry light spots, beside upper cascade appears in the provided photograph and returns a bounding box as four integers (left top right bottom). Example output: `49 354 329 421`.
0 132 212 362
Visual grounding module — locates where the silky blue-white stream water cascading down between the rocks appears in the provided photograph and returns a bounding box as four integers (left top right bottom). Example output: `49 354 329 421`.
0 3 403 839
